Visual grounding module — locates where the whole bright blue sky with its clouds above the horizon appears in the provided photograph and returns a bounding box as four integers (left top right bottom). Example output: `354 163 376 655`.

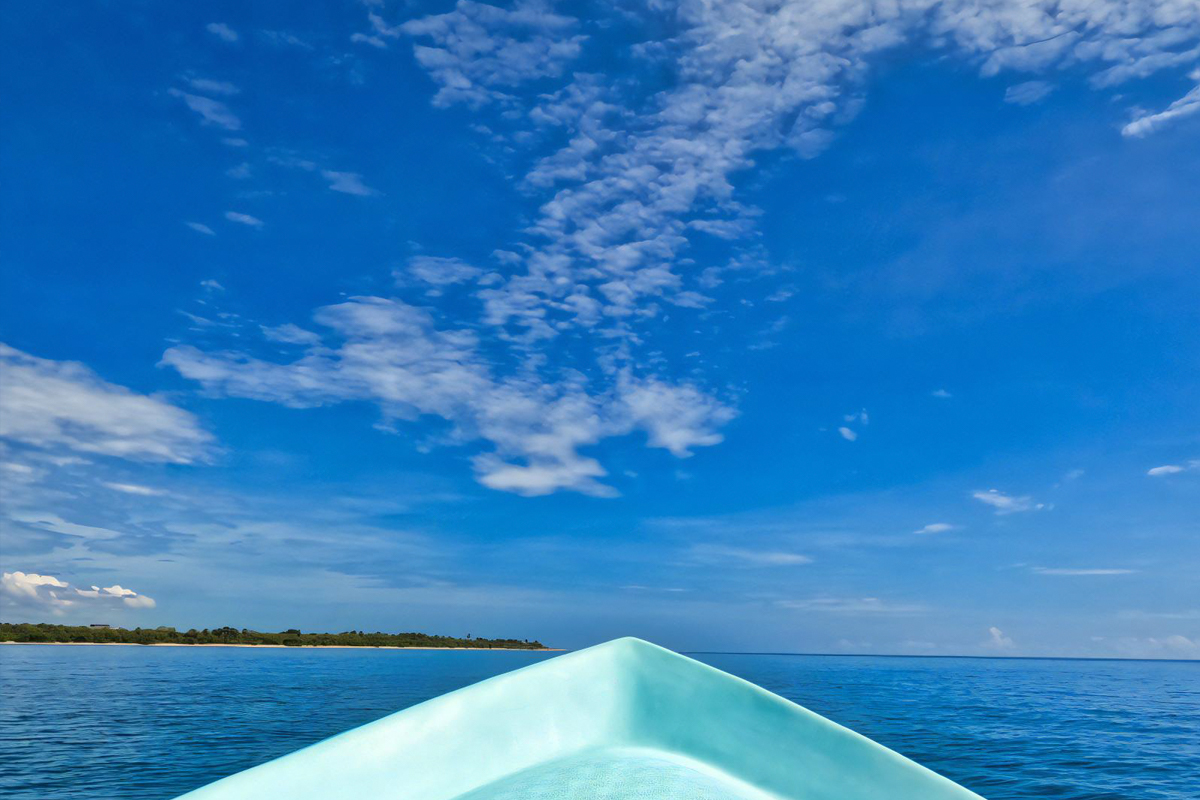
0 0 1200 657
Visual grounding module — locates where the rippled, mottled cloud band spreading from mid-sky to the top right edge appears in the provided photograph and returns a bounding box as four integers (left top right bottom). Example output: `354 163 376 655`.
374 0 1200 339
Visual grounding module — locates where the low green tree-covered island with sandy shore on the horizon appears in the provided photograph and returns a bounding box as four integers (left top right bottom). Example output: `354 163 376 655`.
0 622 548 650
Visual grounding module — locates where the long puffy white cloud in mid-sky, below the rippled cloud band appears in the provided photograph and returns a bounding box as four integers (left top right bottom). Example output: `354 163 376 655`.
162 297 733 497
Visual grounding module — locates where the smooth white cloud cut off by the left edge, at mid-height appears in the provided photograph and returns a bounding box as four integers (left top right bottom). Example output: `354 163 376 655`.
0 344 212 464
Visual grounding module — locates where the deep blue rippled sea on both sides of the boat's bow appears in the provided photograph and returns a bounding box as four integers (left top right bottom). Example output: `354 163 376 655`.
0 645 1200 800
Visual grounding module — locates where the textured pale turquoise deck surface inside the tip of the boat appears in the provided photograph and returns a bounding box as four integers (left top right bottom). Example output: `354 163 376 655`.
456 747 772 800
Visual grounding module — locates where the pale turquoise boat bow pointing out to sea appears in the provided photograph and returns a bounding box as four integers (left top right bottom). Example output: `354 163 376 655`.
177 638 982 800
